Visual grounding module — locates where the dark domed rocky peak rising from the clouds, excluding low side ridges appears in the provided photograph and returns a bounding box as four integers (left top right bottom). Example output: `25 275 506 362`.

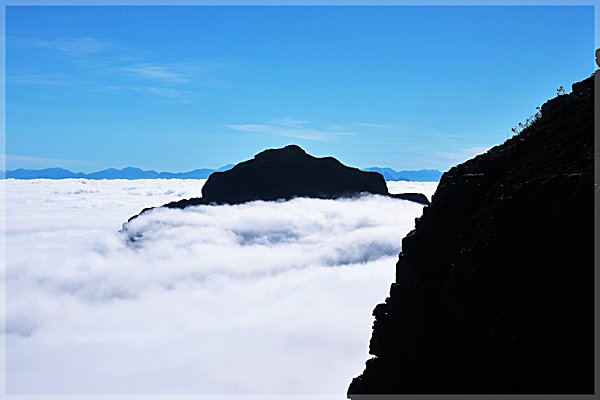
202 145 387 204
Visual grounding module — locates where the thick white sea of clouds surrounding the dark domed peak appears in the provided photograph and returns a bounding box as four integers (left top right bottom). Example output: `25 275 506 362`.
4 179 436 398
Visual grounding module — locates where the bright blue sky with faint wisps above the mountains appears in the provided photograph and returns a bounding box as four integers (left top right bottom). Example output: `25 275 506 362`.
6 6 595 172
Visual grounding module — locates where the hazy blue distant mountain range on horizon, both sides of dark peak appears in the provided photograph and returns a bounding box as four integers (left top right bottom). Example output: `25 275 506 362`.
0 164 442 182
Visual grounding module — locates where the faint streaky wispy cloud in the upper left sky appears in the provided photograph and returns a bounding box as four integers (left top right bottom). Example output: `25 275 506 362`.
8 36 230 101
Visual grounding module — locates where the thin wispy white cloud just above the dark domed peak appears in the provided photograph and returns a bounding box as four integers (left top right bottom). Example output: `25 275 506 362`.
225 117 355 141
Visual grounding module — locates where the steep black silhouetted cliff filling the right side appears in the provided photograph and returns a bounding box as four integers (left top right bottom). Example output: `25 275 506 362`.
348 76 594 398
